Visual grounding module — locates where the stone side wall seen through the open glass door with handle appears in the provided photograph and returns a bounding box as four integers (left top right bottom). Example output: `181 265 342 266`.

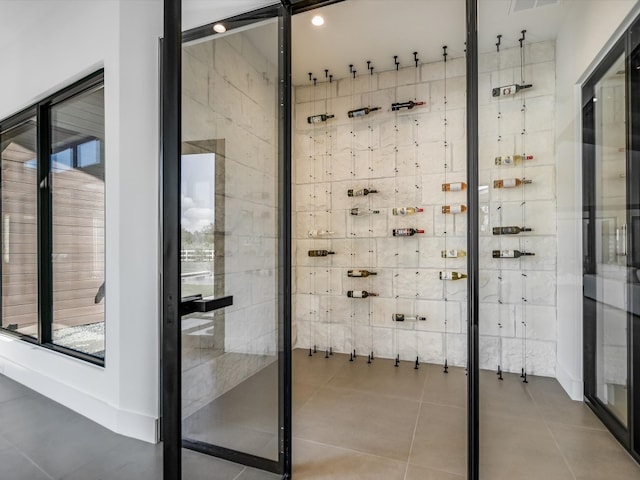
182 22 278 414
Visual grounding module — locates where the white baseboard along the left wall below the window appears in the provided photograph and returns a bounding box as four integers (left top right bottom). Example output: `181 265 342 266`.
0 350 159 443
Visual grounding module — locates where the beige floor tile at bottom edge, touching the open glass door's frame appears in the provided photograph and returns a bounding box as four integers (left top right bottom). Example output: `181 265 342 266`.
293 438 406 480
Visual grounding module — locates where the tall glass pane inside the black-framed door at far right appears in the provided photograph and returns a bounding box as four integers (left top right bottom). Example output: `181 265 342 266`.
594 55 628 425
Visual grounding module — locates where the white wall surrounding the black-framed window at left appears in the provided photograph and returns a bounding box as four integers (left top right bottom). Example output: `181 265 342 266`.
0 0 162 442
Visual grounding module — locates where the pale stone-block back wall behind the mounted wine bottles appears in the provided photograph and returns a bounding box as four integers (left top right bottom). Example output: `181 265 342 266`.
294 42 557 375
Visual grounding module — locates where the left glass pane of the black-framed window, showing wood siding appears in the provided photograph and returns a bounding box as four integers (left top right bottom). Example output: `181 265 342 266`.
0 118 38 338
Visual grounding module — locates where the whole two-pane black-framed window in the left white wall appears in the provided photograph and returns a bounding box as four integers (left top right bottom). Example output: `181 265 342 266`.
0 71 106 364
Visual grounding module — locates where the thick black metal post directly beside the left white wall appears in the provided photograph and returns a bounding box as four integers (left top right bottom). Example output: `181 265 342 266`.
160 0 182 480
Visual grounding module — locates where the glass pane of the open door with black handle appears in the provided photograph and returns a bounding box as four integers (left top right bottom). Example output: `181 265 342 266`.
181 19 280 461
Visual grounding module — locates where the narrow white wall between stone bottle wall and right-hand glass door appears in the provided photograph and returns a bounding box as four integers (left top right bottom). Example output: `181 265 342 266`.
556 0 639 400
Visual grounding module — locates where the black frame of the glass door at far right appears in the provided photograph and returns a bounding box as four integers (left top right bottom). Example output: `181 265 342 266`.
582 13 640 461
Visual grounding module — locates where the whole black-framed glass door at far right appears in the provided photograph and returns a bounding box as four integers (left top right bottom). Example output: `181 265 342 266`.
583 22 640 458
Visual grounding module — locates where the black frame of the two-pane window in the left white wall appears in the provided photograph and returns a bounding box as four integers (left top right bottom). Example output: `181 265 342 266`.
0 68 107 367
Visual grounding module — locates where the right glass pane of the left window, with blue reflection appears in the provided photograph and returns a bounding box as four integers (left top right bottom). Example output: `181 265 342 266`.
51 88 105 358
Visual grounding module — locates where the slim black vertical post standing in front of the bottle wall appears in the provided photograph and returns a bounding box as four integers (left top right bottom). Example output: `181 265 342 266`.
467 0 480 480
